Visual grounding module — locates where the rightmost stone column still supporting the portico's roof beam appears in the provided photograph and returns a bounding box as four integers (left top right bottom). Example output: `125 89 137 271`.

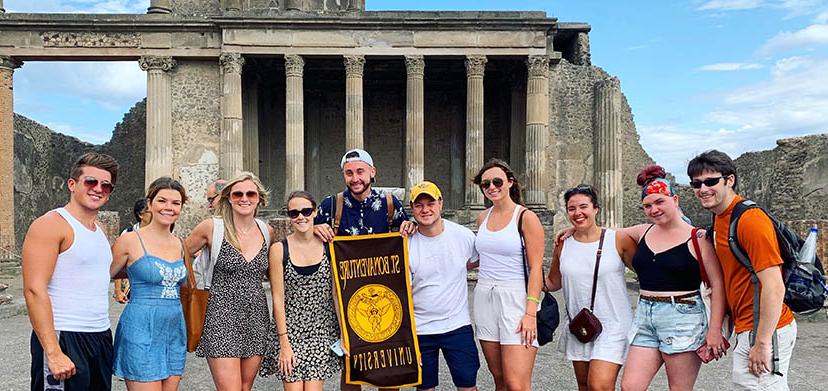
524 56 549 209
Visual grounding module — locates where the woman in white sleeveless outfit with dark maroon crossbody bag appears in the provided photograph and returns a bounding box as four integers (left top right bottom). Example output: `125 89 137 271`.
545 185 636 391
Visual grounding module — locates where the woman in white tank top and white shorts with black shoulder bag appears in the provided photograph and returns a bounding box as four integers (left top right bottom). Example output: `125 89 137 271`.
474 159 544 390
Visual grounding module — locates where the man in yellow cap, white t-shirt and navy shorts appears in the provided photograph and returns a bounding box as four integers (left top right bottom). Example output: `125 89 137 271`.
408 181 480 391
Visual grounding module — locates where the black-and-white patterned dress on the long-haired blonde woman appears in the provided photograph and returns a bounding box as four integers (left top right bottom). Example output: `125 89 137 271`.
196 240 271 357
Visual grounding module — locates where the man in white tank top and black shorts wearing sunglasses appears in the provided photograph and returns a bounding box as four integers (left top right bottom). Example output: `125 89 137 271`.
23 152 118 390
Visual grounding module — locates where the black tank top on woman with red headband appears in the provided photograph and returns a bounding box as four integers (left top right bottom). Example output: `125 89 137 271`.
633 225 701 292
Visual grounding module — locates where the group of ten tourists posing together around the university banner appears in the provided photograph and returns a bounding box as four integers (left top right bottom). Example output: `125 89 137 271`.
23 149 796 390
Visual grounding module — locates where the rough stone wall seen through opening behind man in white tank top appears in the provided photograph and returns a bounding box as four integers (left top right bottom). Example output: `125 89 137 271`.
14 101 146 246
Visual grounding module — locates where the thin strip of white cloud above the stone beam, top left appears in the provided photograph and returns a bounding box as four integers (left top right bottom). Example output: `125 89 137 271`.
5 0 149 14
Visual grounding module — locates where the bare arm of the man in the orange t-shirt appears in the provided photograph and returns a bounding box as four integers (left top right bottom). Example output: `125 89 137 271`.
748 266 785 376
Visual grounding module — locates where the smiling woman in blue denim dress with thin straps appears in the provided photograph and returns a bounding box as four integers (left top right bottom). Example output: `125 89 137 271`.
110 177 187 390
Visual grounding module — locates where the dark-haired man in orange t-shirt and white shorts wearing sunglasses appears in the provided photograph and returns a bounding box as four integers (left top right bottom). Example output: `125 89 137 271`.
687 150 796 390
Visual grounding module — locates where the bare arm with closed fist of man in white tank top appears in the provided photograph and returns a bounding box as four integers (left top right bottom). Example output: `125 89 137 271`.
23 213 75 380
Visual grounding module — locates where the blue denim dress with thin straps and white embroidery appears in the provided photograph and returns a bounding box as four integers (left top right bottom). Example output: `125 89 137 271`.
112 235 187 382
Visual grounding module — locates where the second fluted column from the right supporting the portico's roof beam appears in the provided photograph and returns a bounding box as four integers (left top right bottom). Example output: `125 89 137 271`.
466 56 488 208
